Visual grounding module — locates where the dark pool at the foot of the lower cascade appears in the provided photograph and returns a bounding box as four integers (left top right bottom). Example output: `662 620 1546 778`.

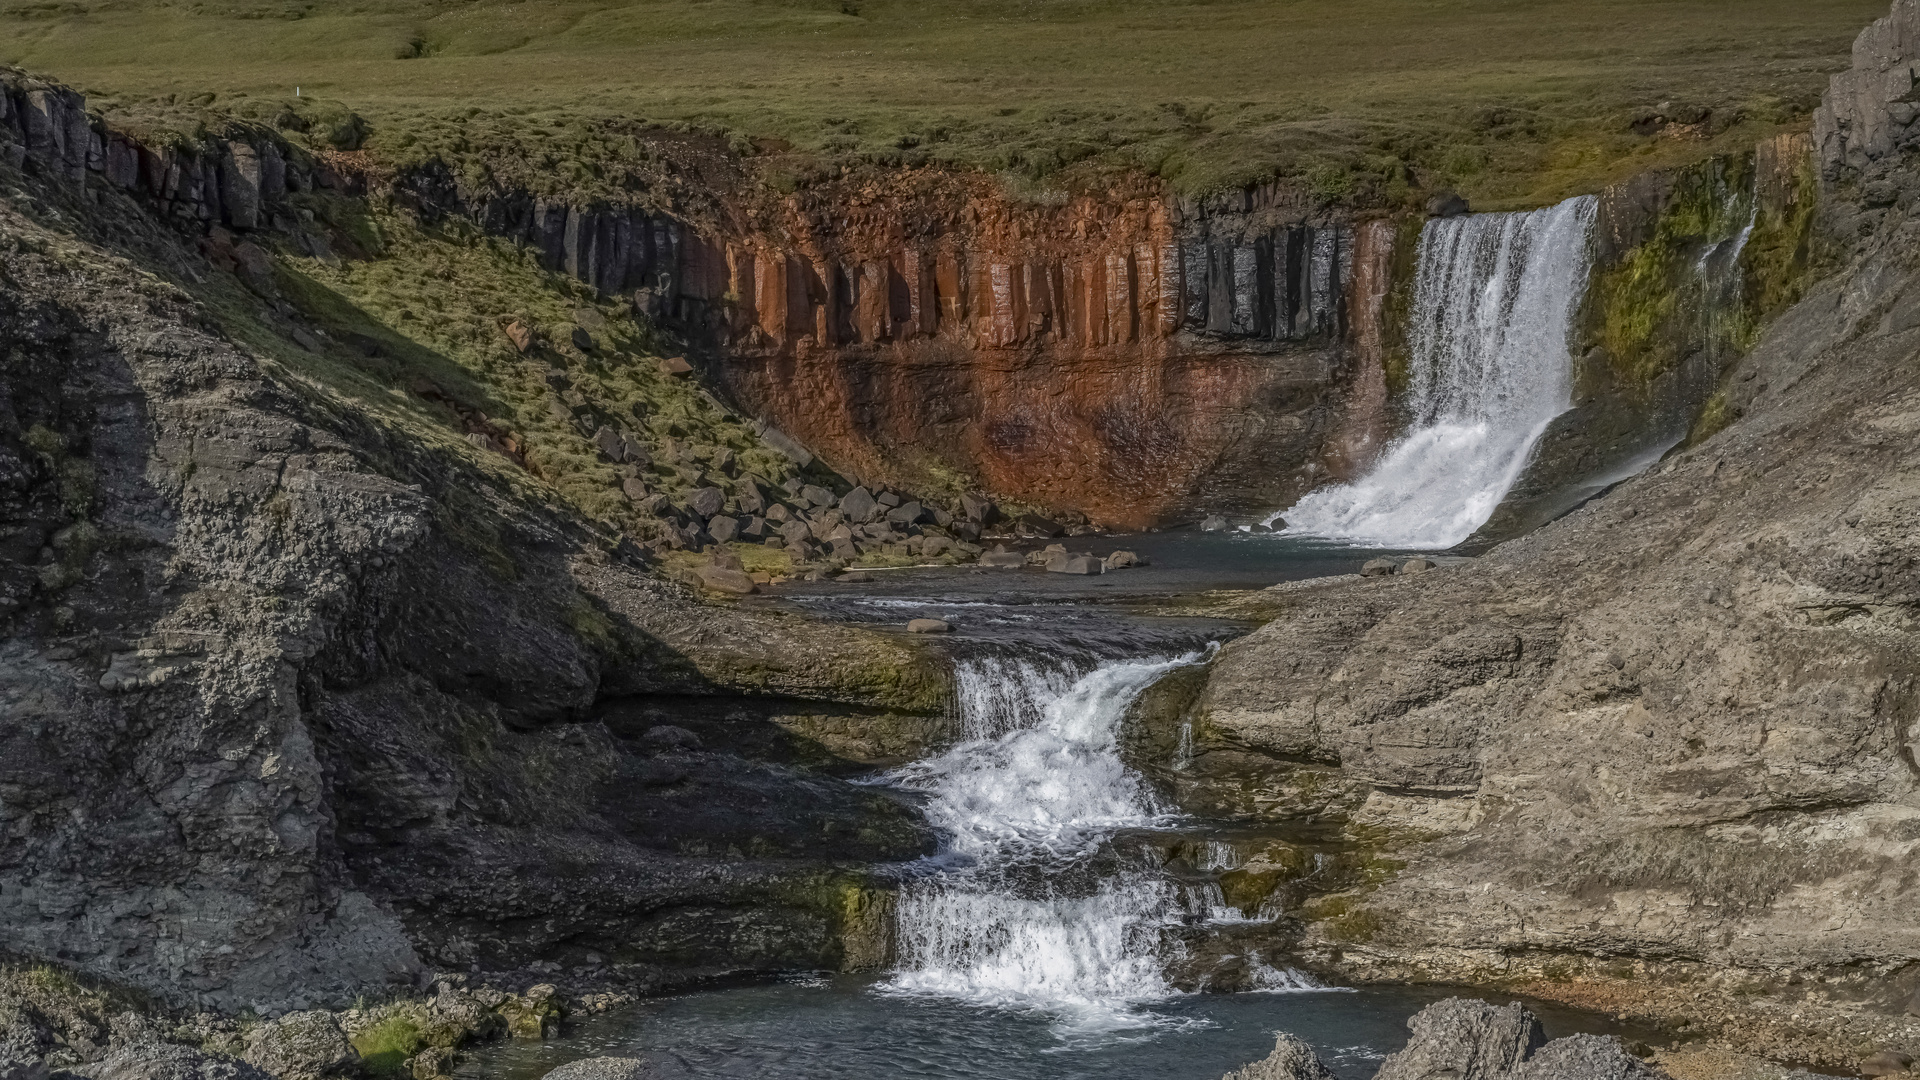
457 976 1658 1080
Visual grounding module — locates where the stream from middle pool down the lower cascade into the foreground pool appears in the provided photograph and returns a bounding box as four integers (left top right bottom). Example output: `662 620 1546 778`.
459 532 1666 1080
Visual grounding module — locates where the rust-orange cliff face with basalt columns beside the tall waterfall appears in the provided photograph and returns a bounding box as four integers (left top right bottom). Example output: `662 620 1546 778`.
698 171 1359 525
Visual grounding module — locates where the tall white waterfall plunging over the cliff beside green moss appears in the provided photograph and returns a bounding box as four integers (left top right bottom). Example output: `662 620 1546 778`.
1279 196 1596 550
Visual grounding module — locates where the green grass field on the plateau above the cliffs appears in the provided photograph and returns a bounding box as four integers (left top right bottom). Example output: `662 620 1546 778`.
0 0 1887 208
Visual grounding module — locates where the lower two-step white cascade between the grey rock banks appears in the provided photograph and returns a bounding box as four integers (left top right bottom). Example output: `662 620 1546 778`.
887 638 1311 1030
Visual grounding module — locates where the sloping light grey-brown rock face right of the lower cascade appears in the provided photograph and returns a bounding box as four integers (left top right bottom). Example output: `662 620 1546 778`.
1192 14 1920 1065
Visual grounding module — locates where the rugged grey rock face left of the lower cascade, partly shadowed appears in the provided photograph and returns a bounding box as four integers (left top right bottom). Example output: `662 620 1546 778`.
0 85 945 1006
